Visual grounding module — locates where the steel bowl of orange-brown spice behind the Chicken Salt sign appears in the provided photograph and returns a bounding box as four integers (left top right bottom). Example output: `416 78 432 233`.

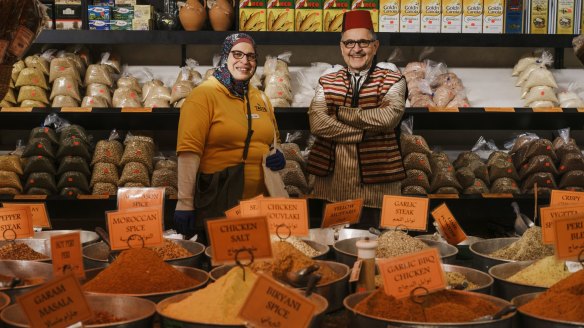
209 260 351 312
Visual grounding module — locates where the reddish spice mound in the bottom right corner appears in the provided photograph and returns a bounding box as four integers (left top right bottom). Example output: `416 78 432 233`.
519 270 584 324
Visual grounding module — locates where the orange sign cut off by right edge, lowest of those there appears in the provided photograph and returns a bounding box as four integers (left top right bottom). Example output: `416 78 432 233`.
554 216 584 260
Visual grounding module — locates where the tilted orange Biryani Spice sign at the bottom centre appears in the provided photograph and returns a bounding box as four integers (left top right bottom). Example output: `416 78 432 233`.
239 274 316 328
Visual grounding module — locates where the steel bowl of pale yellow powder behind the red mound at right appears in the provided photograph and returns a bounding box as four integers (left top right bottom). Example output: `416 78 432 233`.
489 261 547 300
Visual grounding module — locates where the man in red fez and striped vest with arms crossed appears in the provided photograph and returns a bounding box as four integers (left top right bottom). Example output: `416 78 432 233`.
307 10 406 227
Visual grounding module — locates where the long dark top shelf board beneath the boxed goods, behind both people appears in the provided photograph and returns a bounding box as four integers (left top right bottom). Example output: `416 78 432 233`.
35 30 574 48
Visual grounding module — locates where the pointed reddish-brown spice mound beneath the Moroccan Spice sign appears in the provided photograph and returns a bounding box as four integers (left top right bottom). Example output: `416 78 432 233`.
83 248 200 294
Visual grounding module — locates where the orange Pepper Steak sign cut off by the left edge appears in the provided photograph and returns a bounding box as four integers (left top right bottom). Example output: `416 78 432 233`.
0 207 34 240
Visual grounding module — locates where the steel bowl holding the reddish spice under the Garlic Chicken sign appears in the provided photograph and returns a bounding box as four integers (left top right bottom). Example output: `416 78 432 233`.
343 291 515 328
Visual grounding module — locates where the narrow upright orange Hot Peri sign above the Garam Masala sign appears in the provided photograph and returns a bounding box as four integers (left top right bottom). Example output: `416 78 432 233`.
51 232 85 278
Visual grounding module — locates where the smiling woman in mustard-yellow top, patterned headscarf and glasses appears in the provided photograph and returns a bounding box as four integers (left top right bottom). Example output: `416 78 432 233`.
174 33 286 239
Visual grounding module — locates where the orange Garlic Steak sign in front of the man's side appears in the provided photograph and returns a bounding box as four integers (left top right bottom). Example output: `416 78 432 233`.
381 195 429 231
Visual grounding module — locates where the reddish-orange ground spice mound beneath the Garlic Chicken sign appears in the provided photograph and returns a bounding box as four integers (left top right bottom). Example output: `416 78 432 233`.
355 289 500 323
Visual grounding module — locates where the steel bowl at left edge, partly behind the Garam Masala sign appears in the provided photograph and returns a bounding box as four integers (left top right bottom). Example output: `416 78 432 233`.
0 260 53 302
